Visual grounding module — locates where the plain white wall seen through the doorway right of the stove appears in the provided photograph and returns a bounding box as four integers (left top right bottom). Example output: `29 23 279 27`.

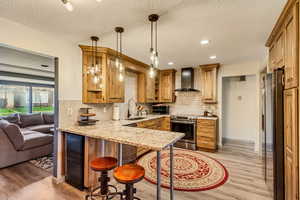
222 75 258 143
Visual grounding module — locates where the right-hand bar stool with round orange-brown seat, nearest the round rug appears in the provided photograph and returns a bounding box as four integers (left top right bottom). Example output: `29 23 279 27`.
114 164 145 200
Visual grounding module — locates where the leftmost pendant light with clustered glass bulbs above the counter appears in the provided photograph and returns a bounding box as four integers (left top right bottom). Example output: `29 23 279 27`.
87 36 101 86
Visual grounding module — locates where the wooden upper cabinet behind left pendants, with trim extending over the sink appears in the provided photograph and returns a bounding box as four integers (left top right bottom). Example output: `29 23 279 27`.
80 45 149 104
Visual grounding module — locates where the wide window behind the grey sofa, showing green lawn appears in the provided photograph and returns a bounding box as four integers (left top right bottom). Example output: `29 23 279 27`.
0 81 54 116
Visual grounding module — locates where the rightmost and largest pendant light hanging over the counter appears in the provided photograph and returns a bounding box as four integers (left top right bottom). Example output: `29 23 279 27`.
148 14 159 78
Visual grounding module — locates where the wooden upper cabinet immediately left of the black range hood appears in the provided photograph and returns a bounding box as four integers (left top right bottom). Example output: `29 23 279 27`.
159 69 176 103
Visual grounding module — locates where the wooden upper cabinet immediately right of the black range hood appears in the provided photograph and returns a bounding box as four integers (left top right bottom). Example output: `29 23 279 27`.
200 64 220 103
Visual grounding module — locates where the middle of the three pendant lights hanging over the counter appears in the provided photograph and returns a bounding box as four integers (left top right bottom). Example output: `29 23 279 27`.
115 27 125 81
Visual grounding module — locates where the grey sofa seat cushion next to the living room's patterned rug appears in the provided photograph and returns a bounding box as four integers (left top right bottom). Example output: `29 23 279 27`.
22 131 53 150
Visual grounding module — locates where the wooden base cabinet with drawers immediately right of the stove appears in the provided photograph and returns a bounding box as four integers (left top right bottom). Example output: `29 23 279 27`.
197 119 218 151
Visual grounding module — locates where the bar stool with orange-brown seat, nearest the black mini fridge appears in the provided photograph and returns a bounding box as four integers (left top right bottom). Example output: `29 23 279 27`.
85 157 118 200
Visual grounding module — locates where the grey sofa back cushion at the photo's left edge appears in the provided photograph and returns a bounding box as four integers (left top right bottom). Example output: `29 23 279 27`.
0 120 24 150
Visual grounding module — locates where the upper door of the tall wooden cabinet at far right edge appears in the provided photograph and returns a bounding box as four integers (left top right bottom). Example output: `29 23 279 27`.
285 6 298 89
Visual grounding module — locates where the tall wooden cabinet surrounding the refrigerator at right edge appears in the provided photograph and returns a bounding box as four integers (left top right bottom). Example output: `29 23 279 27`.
266 0 299 200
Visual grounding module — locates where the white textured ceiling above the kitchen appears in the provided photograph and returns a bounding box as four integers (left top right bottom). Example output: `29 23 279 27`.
0 0 286 68
